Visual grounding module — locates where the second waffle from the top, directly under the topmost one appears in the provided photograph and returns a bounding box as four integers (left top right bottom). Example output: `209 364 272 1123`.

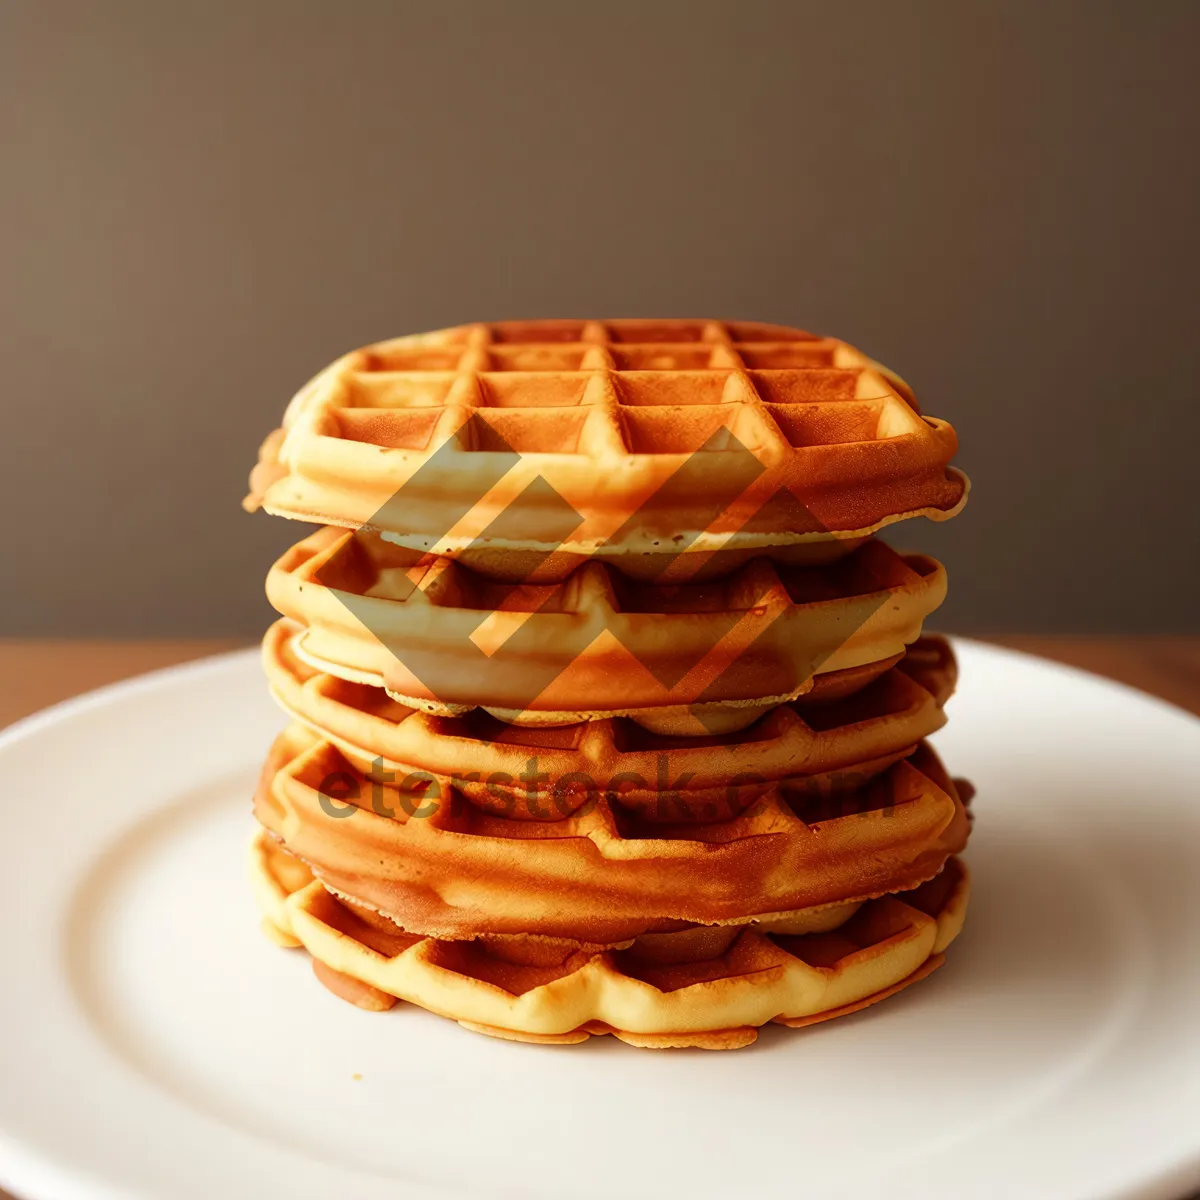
266 528 946 733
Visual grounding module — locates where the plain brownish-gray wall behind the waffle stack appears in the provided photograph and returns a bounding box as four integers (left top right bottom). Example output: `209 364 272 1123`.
0 0 1200 635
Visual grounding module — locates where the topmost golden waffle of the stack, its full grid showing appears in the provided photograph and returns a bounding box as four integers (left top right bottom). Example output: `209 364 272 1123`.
246 320 967 580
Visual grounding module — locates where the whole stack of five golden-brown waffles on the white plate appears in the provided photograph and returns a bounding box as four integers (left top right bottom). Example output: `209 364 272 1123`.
247 320 970 1049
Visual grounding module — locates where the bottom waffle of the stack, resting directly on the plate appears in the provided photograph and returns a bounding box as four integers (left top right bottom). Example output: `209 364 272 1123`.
251 834 968 1049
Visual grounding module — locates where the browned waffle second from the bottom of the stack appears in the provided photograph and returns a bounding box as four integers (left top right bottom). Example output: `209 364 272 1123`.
254 725 968 943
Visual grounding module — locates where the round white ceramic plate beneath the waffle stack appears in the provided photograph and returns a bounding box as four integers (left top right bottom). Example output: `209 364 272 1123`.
0 643 1200 1200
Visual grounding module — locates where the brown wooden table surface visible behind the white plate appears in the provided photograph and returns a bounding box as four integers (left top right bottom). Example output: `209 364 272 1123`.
0 636 1200 1200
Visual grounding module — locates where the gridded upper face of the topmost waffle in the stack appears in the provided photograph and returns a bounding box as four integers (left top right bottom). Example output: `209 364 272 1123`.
292 322 922 460
